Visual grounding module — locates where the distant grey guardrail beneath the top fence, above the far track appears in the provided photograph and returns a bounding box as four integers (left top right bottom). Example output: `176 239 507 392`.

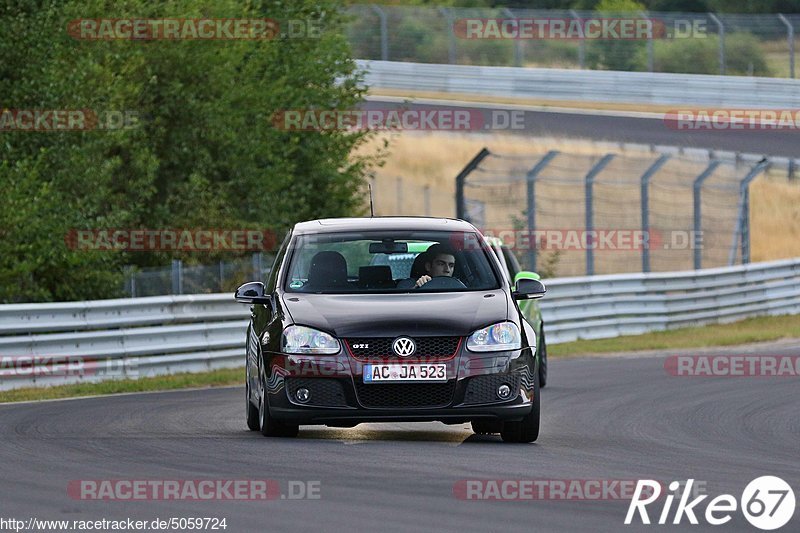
357 60 800 109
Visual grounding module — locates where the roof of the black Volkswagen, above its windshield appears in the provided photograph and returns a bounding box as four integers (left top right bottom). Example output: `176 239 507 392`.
294 217 476 234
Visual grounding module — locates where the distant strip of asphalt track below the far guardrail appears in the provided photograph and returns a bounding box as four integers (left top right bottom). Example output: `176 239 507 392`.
364 96 800 158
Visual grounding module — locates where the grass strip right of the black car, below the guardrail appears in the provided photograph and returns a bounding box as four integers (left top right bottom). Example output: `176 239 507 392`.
545 315 800 357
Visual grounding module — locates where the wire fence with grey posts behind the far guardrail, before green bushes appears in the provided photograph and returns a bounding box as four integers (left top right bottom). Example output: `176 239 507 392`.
347 5 800 78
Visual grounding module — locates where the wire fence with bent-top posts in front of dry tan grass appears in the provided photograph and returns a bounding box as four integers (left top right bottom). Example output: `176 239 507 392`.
456 150 769 277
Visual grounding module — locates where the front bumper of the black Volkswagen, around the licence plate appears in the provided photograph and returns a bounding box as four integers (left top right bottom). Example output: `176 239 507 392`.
267 348 537 426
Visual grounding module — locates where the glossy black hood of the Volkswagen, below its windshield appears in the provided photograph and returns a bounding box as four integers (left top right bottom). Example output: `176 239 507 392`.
283 289 509 337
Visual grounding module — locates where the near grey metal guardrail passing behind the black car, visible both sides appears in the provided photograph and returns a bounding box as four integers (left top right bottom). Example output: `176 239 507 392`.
0 258 800 390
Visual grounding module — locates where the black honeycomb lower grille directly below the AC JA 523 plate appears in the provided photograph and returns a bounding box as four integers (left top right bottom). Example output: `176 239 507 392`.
356 380 456 407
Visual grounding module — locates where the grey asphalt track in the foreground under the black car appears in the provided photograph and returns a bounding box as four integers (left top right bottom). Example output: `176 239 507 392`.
0 341 800 532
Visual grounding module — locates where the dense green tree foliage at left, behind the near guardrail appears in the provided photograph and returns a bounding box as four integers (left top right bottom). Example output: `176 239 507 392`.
0 0 377 302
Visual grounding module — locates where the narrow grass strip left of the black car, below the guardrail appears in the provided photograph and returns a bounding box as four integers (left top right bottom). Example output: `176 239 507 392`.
0 368 244 402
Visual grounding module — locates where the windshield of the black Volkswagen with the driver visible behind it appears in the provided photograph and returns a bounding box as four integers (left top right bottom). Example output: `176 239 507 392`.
284 231 500 294
